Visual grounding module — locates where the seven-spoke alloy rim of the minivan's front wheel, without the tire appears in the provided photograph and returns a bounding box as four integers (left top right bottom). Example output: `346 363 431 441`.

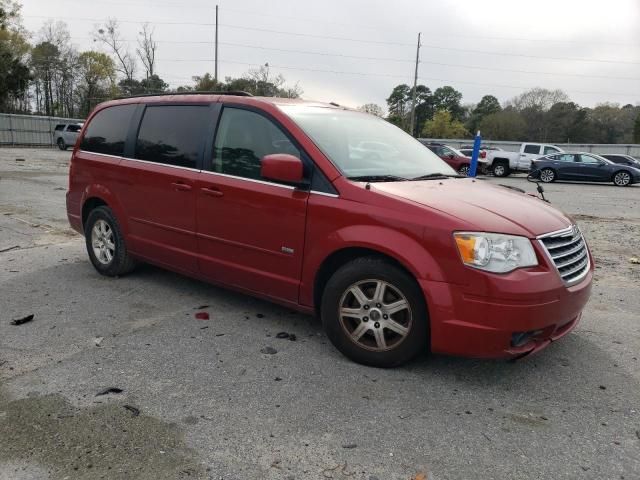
338 279 413 352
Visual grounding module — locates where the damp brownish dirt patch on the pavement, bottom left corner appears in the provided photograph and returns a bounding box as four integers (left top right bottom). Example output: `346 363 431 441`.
0 384 207 480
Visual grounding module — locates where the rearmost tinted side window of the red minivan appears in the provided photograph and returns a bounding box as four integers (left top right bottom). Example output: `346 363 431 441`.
80 104 136 156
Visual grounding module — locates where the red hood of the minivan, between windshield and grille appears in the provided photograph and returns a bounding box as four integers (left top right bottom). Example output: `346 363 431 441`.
371 178 573 238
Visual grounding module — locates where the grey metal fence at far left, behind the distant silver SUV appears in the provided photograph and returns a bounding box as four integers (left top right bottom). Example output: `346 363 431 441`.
0 113 84 147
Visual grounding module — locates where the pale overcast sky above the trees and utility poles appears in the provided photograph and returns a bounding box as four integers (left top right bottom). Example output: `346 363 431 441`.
22 0 640 107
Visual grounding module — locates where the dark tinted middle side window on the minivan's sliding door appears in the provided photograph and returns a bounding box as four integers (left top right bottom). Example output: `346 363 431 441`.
136 105 209 168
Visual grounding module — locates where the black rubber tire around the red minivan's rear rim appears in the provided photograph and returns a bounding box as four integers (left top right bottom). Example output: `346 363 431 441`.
84 206 136 277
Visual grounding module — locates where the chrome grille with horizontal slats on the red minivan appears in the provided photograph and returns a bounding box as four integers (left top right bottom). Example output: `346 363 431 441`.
538 225 590 285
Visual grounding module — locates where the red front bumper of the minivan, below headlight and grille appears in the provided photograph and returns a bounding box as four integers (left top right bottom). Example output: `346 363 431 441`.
420 262 593 358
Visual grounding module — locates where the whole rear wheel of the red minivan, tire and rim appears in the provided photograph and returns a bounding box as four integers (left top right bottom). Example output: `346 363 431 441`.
84 206 136 277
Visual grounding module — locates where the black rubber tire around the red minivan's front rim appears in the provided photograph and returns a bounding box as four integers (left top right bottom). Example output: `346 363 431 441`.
320 257 430 368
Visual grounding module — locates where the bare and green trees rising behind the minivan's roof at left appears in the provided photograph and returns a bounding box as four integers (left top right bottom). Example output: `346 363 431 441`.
0 0 302 118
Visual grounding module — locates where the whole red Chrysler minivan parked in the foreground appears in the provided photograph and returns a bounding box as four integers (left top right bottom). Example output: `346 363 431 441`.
67 93 593 367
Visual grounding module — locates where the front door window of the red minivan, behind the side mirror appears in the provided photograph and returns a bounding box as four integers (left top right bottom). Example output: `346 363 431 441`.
213 107 300 179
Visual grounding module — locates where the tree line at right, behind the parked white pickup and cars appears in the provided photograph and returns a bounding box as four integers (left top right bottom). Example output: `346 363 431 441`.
380 84 640 143
